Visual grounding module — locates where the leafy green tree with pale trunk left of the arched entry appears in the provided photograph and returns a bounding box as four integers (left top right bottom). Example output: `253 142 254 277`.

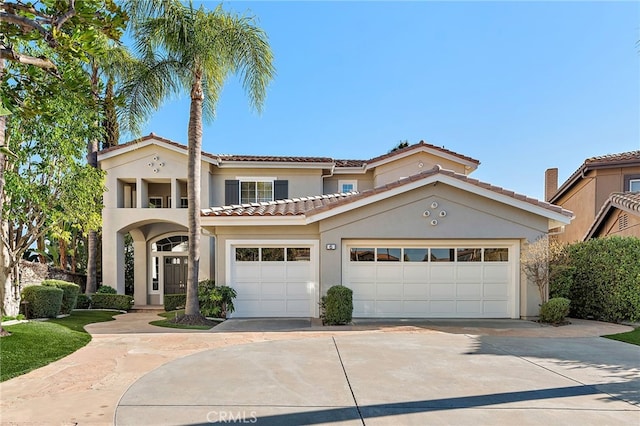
0 63 104 314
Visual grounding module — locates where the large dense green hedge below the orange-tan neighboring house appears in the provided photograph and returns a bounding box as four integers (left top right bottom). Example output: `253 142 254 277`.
550 236 640 322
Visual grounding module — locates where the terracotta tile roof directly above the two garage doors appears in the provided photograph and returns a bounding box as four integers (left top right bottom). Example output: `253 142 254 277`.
203 166 573 217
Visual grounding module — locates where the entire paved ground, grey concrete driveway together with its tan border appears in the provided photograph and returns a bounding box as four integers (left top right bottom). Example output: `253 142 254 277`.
0 314 640 425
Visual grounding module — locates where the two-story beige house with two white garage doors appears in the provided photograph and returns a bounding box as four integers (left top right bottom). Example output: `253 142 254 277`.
98 134 572 318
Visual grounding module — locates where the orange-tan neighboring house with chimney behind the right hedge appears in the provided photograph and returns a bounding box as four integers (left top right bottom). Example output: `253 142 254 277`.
545 151 640 243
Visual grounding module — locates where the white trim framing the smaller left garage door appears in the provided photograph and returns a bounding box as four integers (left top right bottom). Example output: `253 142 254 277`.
226 239 320 318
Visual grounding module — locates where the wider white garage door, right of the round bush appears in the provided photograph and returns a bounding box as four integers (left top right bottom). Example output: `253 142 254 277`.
343 241 518 318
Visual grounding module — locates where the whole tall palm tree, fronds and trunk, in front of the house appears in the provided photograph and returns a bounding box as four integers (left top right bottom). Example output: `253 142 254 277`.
125 0 275 321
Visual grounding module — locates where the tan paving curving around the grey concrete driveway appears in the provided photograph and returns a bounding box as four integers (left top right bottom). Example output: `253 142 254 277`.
0 313 632 425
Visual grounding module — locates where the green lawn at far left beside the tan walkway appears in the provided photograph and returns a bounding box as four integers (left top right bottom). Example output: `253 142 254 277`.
0 311 119 382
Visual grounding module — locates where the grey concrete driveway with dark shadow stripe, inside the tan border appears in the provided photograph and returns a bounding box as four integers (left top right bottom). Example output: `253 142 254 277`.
115 321 640 425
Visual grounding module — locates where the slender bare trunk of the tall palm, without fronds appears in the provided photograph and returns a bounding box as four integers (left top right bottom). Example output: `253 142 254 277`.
184 72 204 317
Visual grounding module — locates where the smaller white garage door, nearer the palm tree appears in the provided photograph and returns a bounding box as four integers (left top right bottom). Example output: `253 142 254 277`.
227 243 317 317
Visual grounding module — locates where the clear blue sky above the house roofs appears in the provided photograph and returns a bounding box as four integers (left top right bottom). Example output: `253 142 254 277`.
130 1 640 199
